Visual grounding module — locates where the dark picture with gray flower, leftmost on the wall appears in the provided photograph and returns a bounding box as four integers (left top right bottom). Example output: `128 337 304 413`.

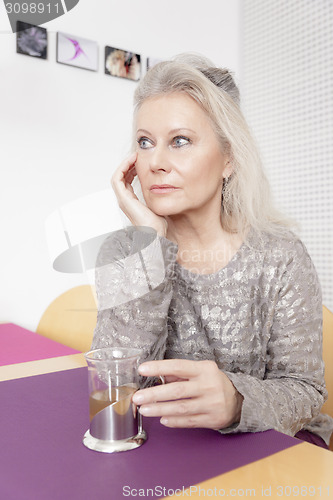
16 21 47 59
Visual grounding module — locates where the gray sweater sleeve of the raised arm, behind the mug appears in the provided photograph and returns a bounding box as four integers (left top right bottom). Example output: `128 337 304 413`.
92 227 177 361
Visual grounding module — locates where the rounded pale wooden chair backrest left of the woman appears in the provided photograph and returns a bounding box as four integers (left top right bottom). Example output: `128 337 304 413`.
37 285 97 352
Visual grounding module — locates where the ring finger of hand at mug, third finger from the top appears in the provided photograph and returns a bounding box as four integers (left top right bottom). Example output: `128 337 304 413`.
139 399 201 417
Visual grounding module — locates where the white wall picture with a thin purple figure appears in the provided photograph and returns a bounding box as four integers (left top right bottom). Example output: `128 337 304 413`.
57 32 98 71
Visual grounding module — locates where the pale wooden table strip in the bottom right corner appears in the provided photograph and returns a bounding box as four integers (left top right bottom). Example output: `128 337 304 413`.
166 441 333 500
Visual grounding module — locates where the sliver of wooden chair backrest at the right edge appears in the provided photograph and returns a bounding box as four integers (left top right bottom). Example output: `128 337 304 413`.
322 306 333 451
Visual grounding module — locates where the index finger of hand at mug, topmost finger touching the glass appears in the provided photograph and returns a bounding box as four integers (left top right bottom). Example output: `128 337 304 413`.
139 359 203 379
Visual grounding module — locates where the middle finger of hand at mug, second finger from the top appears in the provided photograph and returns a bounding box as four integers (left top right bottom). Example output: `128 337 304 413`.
132 380 198 405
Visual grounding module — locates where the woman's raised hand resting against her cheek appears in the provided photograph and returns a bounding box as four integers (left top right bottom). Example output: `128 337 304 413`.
111 153 168 237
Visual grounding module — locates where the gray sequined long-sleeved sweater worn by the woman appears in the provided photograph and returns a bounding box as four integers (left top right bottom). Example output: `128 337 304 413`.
92 227 333 443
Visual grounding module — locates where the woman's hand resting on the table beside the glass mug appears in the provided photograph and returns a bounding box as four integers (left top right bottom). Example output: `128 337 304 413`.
133 359 243 429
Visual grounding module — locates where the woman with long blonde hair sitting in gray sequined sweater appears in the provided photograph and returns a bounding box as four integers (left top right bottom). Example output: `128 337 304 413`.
93 55 333 446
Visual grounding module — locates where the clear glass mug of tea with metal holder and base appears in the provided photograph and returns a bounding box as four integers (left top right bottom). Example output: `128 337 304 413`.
83 347 164 453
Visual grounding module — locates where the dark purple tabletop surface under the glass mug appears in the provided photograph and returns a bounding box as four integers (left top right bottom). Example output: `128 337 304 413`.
0 368 299 500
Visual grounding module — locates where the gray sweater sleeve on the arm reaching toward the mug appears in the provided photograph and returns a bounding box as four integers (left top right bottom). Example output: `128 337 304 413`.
220 241 327 436
